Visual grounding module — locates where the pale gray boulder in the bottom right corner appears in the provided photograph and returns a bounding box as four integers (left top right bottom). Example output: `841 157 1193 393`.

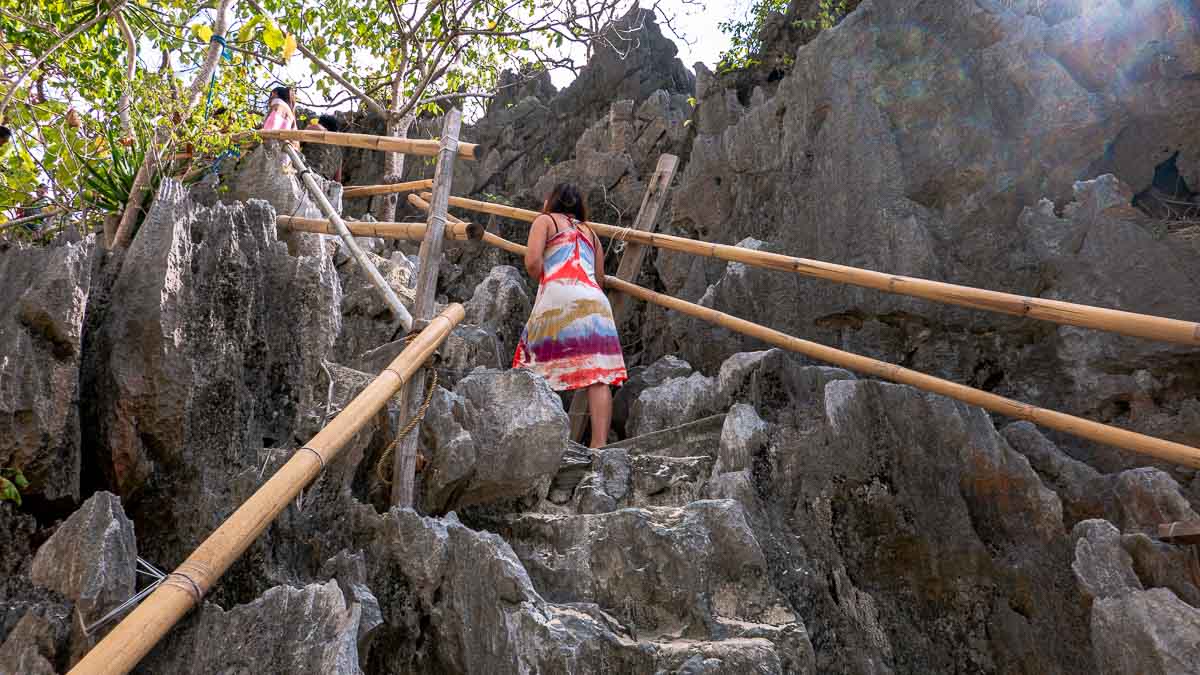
1092 589 1200 675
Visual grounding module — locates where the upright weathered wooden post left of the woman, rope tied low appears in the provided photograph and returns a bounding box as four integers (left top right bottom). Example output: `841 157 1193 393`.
391 108 462 507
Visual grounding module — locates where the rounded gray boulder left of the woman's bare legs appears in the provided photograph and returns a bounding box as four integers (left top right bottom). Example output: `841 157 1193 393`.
421 370 568 513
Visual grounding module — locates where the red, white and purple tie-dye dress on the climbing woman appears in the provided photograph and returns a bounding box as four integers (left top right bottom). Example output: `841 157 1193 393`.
512 216 628 392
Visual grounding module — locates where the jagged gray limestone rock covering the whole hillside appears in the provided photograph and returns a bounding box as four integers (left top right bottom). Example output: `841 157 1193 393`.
0 0 1200 675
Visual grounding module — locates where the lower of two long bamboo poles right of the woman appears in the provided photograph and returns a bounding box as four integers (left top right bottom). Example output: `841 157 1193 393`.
606 276 1200 467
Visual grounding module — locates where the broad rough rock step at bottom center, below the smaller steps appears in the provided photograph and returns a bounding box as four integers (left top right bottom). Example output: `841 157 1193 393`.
500 500 811 673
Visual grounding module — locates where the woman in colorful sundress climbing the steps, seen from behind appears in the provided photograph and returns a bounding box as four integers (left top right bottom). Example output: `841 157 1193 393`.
512 183 628 448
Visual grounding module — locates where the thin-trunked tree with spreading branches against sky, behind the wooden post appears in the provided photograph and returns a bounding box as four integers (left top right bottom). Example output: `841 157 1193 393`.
238 0 637 220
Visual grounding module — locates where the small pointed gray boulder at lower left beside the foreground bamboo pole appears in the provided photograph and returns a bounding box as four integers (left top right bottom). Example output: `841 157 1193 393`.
30 485 138 623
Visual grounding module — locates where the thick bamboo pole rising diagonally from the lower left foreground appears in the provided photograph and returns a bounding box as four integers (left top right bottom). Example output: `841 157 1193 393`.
71 304 464 675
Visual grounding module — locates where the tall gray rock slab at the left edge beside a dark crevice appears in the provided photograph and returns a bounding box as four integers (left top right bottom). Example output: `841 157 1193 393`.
0 238 96 503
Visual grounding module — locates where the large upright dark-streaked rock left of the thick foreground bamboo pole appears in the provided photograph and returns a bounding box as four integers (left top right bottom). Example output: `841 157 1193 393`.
89 180 341 586
